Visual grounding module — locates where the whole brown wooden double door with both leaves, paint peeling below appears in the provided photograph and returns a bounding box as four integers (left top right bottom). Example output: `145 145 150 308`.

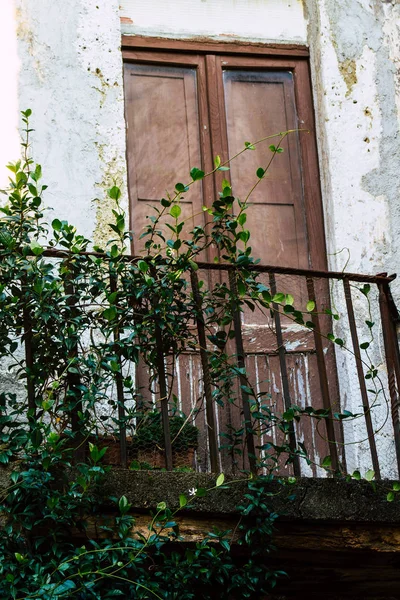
125 49 337 472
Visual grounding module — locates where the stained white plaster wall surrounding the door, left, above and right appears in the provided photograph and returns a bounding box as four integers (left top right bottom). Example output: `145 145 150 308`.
0 0 400 475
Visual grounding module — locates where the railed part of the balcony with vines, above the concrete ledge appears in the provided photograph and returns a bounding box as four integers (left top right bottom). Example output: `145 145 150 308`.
1 249 400 479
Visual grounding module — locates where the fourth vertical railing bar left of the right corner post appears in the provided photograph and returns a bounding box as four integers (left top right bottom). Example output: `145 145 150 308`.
229 271 257 473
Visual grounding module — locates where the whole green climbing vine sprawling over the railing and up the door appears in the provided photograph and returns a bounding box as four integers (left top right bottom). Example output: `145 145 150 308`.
0 110 390 600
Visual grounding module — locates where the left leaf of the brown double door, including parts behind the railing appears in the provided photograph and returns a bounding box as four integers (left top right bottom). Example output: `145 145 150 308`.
124 52 217 470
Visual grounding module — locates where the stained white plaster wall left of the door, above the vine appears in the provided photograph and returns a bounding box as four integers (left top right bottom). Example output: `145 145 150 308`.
7 0 126 243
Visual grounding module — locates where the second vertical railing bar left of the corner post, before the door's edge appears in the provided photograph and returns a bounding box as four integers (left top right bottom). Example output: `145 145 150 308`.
306 277 339 471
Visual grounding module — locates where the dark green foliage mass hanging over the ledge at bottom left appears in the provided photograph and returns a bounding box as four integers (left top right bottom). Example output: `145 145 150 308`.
0 442 280 600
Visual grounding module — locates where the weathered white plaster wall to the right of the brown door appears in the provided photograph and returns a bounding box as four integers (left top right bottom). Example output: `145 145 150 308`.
306 0 400 476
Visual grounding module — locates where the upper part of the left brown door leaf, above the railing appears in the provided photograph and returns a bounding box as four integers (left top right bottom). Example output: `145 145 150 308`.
124 57 212 253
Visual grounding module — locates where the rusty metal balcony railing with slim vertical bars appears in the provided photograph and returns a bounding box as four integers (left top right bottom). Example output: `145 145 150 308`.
14 249 400 478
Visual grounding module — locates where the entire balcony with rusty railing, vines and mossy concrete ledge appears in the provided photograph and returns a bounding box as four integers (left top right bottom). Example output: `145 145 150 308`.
0 245 400 600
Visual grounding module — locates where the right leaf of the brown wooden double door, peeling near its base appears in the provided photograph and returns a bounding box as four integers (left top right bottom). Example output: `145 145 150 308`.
207 56 340 475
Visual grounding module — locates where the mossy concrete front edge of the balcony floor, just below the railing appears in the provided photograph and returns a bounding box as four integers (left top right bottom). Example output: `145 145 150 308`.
97 469 400 524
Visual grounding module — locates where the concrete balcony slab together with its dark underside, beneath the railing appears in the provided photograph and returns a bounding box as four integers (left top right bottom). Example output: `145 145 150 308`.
0 468 400 600
